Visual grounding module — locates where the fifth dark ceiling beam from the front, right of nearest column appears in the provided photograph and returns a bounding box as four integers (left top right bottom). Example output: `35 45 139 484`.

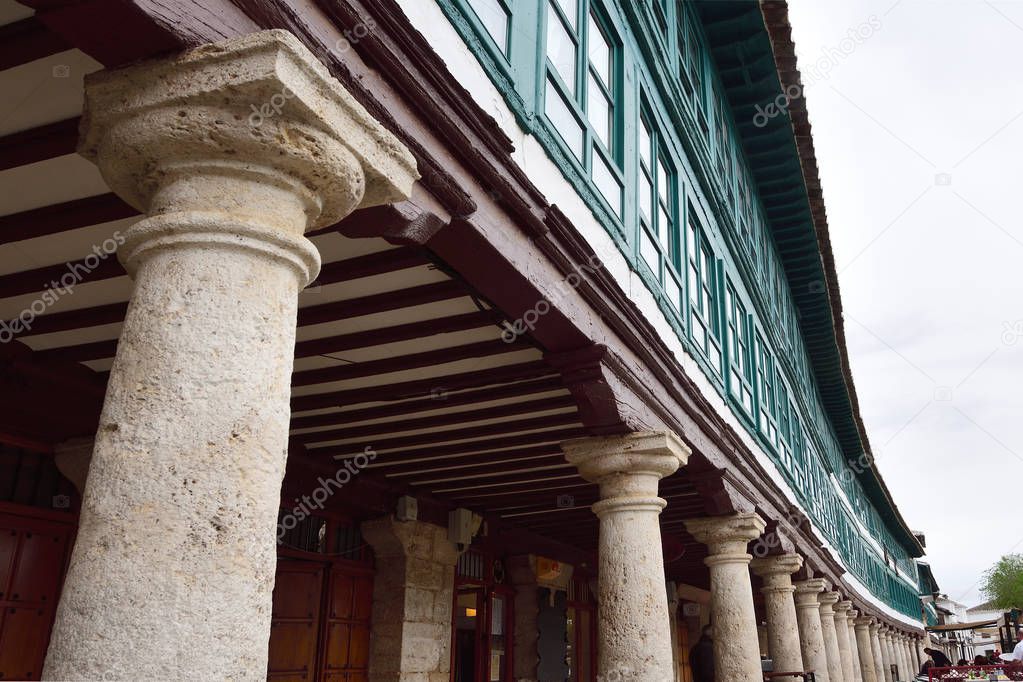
292 360 551 412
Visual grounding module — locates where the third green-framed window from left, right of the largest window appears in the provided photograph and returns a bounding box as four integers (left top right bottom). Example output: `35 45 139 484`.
636 104 684 314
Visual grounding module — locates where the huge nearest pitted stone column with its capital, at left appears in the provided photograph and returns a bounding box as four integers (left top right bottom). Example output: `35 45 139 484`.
44 31 417 680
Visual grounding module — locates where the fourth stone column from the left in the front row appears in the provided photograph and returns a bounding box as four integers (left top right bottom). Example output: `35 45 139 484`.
750 554 804 672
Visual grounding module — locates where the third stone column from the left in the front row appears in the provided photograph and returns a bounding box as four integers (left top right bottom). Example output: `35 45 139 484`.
685 513 767 682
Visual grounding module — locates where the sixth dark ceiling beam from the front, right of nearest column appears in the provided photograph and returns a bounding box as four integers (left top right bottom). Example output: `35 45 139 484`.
292 378 562 428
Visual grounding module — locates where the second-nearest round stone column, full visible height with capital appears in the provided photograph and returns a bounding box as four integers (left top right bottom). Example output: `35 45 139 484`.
562 433 690 682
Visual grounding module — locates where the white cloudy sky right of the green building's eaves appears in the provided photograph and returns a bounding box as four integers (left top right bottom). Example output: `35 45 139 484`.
790 0 1023 606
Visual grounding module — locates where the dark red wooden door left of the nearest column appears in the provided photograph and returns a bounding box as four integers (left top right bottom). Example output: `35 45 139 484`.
0 510 75 680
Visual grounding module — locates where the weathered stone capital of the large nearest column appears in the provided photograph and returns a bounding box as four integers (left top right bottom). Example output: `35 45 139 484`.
79 30 418 280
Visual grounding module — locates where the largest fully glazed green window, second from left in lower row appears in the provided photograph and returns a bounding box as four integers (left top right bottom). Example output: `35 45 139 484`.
539 0 625 215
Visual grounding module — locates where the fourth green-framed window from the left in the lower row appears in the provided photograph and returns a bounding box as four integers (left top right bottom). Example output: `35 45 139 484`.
685 213 721 376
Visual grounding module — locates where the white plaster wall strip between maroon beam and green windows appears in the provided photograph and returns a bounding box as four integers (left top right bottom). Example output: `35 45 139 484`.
398 0 920 627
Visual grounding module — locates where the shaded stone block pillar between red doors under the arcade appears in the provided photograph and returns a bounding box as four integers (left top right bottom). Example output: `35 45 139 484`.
361 516 458 682
